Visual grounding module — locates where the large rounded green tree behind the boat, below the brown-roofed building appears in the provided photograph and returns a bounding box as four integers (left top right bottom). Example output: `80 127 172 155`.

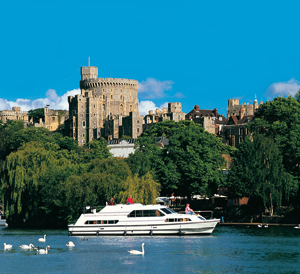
128 120 225 196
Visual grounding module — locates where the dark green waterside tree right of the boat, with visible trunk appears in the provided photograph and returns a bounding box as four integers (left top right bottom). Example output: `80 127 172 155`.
228 134 295 216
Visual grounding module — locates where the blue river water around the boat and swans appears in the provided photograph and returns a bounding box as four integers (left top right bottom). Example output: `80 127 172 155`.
0 227 300 273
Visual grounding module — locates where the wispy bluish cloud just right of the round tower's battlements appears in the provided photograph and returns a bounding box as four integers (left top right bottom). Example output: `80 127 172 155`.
138 78 174 99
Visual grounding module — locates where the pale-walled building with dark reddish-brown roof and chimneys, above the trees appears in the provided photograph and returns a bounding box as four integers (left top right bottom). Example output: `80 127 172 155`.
185 105 227 136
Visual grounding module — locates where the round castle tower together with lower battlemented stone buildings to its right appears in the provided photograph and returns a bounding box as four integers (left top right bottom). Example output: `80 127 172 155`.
65 66 184 145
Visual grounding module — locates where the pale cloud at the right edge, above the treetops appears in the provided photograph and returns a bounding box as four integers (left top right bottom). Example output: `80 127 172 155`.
265 78 300 98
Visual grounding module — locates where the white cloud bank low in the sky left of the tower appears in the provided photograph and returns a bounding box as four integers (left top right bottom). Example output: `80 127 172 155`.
0 89 81 111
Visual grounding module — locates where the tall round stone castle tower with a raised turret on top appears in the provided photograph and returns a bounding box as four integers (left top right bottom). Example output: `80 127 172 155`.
66 66 139 145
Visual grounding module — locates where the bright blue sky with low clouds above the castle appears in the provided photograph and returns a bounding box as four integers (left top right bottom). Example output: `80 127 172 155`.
0 0 300 115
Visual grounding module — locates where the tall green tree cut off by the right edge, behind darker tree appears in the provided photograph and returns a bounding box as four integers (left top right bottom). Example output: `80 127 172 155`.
249 97 300 201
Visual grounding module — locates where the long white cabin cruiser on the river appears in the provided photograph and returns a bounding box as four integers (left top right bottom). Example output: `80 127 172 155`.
68 204 220 236
